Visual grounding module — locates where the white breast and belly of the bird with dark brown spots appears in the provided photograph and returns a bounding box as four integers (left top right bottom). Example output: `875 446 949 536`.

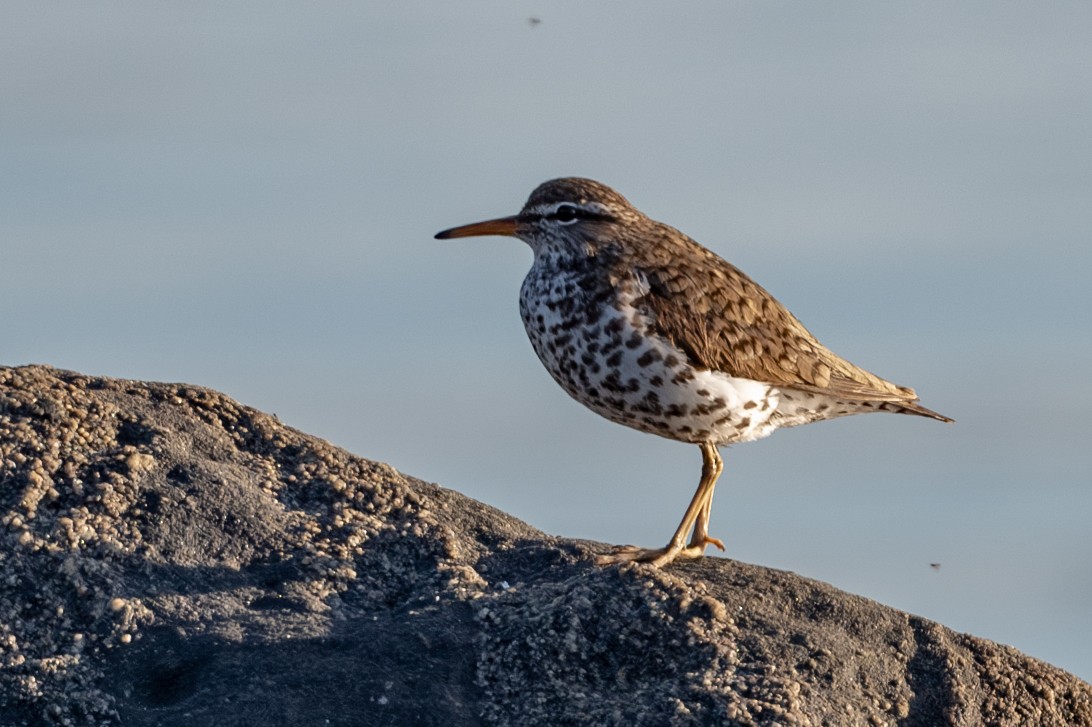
520 246 780 444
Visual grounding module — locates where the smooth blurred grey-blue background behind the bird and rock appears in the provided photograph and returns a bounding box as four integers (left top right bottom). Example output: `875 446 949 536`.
0 0 1092 680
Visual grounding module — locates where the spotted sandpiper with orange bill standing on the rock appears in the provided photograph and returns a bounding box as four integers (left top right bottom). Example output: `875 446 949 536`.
436 177 952 567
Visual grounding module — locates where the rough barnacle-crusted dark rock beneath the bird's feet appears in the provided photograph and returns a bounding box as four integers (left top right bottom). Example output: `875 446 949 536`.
0 367 1092 727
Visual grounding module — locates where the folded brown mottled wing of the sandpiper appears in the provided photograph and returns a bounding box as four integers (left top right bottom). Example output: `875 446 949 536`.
634 231 931 401
